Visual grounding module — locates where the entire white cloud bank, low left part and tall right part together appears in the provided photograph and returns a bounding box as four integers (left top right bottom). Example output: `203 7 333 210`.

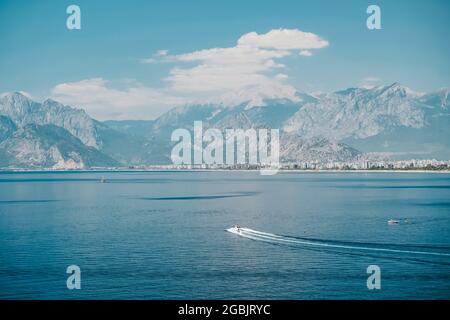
52 29 329 119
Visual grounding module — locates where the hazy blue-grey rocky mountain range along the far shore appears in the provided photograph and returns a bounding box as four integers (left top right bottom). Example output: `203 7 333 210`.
0 83 450 169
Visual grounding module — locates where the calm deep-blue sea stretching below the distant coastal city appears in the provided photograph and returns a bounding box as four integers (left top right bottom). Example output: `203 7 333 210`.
0 171 450 299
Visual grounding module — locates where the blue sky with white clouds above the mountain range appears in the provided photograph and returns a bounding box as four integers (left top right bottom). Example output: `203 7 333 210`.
0 0 450 120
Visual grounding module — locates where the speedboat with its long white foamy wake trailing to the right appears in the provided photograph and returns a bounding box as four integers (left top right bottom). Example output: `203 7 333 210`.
227 227 450 258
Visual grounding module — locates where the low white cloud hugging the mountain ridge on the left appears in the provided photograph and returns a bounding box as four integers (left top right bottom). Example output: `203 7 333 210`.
52 78 189 120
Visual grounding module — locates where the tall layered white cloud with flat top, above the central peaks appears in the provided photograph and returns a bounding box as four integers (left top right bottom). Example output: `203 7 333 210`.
164 29 328 93
